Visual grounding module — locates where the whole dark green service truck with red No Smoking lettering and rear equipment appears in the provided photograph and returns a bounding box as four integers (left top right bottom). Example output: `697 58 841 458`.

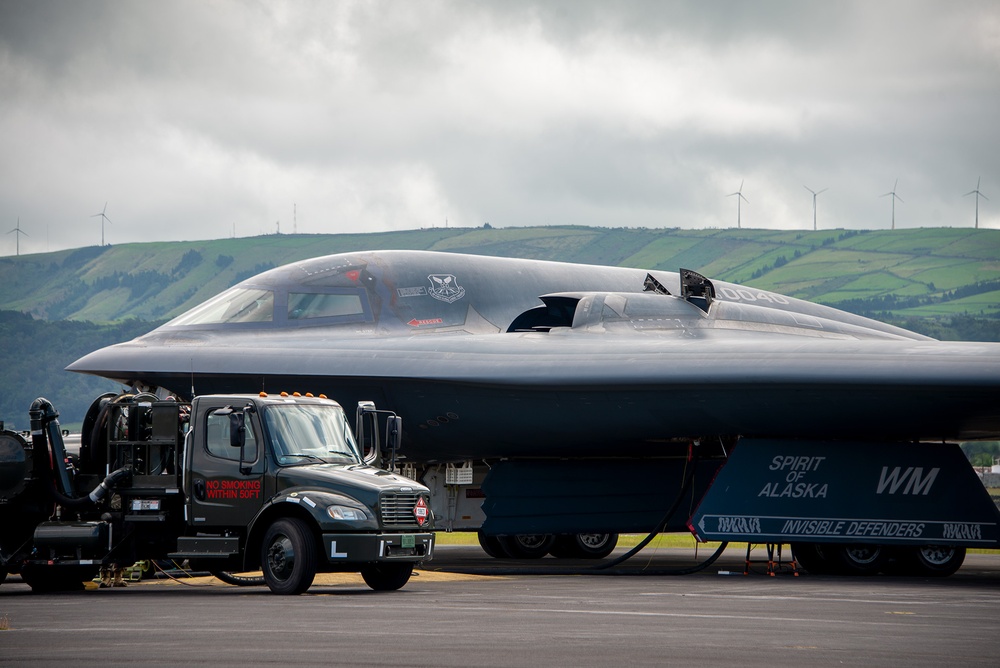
0 393 434 594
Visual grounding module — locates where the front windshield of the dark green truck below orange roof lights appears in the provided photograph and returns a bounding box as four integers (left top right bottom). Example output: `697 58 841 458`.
264 404 361 466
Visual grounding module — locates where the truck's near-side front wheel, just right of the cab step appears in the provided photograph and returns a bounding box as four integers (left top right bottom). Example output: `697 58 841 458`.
260 517 317 594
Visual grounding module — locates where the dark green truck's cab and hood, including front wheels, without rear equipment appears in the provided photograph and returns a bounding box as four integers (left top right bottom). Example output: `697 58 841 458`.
178 393 433 591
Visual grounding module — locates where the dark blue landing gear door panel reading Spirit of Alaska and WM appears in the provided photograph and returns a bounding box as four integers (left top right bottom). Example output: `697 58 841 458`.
688 439 1000 548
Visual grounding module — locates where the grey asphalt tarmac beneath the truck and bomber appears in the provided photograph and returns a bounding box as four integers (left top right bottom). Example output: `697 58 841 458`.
0 546 1000 668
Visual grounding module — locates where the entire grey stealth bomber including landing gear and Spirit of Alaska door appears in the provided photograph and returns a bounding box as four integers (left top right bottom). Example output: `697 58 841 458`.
69 251 1000 574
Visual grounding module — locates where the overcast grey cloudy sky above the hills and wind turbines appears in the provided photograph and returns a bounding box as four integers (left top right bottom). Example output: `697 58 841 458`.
0 0 1000 255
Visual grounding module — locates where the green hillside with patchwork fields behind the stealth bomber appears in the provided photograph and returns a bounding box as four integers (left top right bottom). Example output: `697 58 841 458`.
0 227 1000 426
